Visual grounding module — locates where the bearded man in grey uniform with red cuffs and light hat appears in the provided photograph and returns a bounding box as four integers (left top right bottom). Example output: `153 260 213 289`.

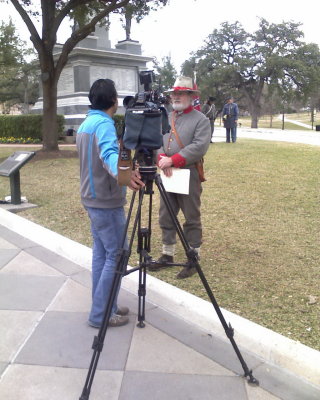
149 76 211 279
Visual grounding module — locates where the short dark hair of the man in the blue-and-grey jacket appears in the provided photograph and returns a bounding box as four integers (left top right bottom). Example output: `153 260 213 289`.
88 79 118 110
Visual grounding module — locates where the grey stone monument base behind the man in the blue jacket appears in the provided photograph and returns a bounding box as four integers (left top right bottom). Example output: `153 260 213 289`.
32 26 153 130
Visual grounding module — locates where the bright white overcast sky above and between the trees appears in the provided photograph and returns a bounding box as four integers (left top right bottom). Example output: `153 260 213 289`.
1 0 320 72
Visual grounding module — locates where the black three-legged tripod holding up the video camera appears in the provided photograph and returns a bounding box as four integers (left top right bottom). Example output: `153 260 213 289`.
79 166 259 400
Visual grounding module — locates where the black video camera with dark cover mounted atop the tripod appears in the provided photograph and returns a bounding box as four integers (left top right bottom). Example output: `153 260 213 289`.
123 71 170 150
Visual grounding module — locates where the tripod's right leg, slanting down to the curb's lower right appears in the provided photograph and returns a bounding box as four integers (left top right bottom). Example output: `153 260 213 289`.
155 175 259 385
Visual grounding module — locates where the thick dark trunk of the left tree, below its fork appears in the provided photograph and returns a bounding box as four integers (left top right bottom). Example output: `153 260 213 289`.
42 79 59 151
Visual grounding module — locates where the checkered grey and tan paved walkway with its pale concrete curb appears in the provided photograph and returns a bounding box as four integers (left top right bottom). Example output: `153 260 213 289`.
0 209 320 400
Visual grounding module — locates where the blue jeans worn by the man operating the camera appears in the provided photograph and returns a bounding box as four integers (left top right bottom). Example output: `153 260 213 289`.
86 207 127 325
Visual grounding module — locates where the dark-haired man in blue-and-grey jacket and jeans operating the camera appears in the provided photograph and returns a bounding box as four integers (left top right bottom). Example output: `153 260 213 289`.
76 79 144 328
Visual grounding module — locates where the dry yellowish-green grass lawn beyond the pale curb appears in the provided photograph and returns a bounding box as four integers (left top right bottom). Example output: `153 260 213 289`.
0 139 320 350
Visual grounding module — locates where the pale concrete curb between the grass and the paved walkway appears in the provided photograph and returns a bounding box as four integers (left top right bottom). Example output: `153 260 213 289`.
0 208 320 386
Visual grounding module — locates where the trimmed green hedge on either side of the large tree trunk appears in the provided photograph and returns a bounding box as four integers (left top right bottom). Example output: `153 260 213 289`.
0 114 64 141
